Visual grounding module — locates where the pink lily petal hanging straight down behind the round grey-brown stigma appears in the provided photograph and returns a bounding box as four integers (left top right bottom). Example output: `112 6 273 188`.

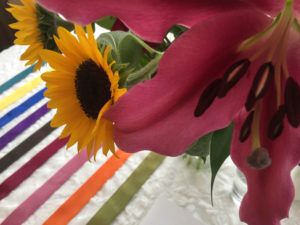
231 84 300 225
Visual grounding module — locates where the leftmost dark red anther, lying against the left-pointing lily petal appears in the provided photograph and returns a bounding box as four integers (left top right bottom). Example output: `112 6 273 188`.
194 78 222 117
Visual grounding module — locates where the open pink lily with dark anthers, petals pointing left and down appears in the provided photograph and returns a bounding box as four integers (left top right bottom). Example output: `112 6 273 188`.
104 3 300 225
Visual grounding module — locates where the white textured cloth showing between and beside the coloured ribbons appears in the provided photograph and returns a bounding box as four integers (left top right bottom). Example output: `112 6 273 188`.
0 46 300 225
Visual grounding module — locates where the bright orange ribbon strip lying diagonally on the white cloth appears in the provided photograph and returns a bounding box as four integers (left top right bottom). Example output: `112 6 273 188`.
44 150 131 225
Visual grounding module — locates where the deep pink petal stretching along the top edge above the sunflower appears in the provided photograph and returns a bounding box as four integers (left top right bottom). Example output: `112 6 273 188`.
38 0 255 43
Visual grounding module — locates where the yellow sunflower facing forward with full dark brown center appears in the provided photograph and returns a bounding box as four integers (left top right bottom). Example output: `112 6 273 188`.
41 25 126 156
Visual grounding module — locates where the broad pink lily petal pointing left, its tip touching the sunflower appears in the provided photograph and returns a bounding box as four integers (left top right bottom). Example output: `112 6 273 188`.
104 10 271 156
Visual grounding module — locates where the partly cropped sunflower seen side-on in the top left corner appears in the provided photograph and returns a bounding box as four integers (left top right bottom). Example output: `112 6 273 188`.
6 0 67 71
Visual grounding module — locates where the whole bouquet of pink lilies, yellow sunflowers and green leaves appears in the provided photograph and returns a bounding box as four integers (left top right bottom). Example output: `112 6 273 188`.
7 0 300 225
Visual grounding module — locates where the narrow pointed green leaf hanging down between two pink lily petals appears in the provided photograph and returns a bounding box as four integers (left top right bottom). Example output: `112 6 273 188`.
210 123 233 204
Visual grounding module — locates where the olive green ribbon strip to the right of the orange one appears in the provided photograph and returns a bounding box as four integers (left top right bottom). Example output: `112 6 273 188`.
88 152 165 225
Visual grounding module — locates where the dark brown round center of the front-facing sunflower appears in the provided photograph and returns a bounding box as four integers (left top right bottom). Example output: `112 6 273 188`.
75 59 111 119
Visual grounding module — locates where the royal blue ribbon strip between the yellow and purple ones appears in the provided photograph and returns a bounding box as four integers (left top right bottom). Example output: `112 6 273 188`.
0 88 47 128
